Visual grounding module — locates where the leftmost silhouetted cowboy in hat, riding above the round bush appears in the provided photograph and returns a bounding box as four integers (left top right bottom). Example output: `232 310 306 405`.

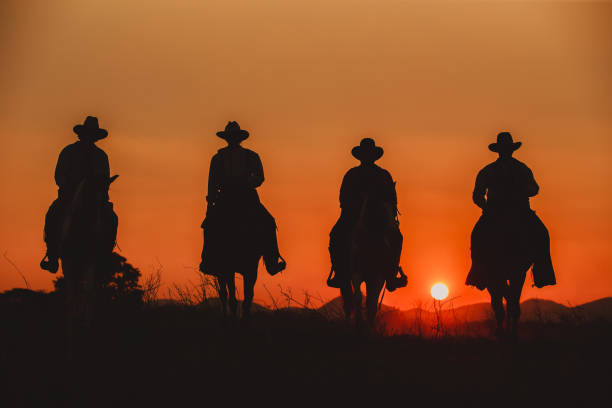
40 116 116 273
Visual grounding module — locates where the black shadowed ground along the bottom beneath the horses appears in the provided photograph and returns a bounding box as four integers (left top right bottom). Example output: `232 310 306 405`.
0 295 612 407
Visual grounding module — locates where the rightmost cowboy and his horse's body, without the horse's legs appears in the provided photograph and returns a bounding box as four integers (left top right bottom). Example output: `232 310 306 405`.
466 132 556 290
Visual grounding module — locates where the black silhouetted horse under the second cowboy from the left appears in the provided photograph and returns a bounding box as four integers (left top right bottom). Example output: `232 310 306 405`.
202 203 275 322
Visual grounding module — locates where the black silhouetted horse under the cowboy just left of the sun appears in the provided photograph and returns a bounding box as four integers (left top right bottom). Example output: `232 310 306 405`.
340 195 397 329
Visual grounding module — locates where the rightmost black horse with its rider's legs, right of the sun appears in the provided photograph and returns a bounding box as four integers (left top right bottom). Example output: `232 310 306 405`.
466 211 556 340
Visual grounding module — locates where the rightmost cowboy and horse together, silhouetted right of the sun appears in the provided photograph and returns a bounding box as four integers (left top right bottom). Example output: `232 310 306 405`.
466 132 556 339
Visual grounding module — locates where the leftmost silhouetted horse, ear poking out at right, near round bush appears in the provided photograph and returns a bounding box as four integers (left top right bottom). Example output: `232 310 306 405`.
59 175 118 336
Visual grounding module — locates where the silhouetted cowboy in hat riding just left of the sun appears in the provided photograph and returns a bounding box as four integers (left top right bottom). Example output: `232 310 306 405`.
327 138 405 291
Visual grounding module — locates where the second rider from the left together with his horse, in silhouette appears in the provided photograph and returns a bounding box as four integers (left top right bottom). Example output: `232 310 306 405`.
200 121 287 320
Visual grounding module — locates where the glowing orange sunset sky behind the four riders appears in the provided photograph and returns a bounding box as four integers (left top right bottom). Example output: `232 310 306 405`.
0 0 612 308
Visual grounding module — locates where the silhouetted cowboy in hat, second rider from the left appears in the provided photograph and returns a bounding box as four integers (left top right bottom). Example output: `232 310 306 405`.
200 122 286 275
